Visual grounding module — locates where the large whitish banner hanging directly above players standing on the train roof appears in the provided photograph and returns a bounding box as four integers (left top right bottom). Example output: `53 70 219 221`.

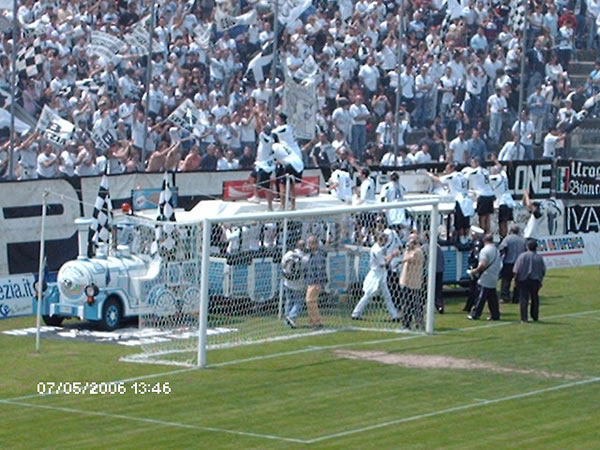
283 76 317 139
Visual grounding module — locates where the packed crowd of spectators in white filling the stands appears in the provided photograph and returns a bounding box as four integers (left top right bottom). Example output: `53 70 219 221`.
0 0 600 179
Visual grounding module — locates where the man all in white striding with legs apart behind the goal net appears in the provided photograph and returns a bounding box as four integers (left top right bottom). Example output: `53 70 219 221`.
352 233 400 322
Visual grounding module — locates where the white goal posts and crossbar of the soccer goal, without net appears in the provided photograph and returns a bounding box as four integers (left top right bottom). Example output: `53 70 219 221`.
196 196 440 368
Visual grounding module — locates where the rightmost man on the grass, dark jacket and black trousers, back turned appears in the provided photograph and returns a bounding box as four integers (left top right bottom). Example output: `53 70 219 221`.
513 239 546 323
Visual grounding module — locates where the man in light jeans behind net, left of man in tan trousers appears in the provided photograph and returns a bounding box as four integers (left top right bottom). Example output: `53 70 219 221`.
281 239 305 328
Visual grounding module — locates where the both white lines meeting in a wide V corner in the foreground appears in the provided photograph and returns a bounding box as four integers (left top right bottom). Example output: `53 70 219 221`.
0 377 600 444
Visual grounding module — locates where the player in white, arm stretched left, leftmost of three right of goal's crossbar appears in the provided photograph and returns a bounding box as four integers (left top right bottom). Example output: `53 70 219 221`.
429 163 475 244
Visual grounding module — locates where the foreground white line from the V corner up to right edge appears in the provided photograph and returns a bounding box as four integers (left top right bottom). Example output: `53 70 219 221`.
306 377 600 444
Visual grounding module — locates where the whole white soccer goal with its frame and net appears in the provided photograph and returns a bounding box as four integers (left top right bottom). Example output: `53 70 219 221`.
127 197 439 367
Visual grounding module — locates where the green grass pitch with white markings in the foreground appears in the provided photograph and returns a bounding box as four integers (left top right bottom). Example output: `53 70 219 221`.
0 267 600 449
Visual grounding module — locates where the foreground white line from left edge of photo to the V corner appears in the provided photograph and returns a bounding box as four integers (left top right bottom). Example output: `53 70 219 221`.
0 400 307 444
